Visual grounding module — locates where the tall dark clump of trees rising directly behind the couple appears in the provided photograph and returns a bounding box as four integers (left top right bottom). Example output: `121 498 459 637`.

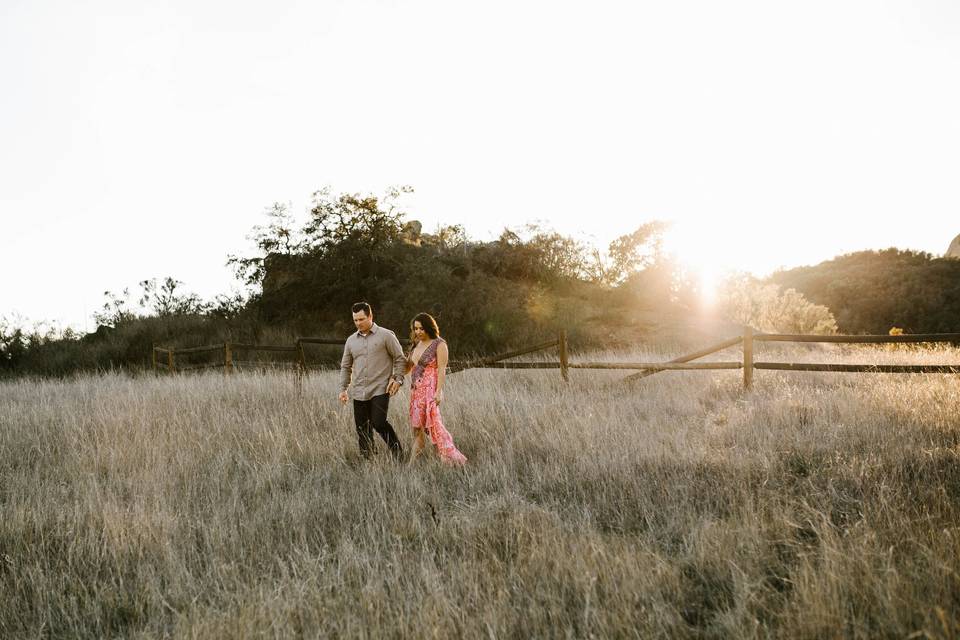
238 189 671 357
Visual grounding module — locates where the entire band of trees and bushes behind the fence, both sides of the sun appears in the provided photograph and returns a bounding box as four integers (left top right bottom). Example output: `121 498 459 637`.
7 187 944 374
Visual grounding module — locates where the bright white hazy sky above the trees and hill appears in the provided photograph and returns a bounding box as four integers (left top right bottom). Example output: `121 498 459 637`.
0 0 960 330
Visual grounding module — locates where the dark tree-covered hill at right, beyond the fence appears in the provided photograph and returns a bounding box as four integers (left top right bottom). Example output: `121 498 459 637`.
770 249 960 334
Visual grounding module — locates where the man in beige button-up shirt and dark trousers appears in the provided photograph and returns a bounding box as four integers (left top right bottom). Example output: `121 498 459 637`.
340 302 406 460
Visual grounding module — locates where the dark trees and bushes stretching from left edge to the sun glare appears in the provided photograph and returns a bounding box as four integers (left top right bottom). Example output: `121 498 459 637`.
0 187 720 375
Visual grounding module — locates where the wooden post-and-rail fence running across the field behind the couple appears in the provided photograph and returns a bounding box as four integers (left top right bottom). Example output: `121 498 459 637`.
152 327 960 388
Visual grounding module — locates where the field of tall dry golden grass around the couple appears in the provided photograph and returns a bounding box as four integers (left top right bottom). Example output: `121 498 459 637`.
0 347 960 638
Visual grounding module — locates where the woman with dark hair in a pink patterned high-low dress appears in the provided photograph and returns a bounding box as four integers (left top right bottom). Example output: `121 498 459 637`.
407 313 467 464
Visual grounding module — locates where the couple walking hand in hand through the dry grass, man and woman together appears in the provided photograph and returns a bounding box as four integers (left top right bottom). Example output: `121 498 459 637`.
340 302 467 465
